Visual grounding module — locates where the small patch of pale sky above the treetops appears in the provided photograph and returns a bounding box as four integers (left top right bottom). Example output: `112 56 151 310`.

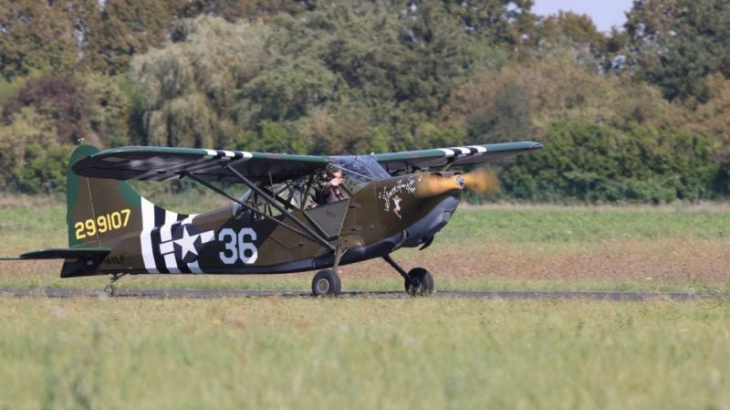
532 0 634 32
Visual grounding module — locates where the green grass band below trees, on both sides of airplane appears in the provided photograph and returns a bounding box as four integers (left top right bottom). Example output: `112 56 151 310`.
0 196 730 249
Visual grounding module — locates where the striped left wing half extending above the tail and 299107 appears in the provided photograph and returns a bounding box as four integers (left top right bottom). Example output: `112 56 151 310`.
72 147 330 183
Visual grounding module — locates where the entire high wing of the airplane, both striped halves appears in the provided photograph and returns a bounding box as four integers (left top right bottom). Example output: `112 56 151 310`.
72 141 542 183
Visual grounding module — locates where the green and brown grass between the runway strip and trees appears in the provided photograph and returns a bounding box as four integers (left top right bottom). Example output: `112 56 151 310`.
0 198 730 292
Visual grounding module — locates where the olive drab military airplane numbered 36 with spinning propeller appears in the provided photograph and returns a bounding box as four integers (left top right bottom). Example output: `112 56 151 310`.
20 141 542 296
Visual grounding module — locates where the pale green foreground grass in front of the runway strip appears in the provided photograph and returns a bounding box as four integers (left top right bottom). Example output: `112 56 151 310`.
0 298 730 409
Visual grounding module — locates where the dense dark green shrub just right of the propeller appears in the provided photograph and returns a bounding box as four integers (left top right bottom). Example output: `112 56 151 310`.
502 122 722 203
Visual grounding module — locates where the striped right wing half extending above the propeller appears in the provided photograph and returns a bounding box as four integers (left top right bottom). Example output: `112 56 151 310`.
375 141 542 174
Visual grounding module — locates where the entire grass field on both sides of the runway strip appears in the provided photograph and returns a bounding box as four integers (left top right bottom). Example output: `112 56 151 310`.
0 198 730 410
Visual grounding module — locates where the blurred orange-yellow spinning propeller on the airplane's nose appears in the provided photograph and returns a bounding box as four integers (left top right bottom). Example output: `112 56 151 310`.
416 168 501 198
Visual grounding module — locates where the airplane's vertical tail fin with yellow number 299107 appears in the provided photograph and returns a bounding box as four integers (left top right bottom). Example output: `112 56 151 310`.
66 145 146 247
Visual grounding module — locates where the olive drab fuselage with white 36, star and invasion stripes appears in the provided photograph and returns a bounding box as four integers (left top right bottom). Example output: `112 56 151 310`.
89 174 460 274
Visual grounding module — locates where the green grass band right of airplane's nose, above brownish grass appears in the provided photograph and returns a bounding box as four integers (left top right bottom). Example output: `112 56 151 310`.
439 206 730 243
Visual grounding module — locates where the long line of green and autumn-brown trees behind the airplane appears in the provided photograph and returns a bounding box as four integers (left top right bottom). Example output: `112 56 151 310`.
0 0 730 203
